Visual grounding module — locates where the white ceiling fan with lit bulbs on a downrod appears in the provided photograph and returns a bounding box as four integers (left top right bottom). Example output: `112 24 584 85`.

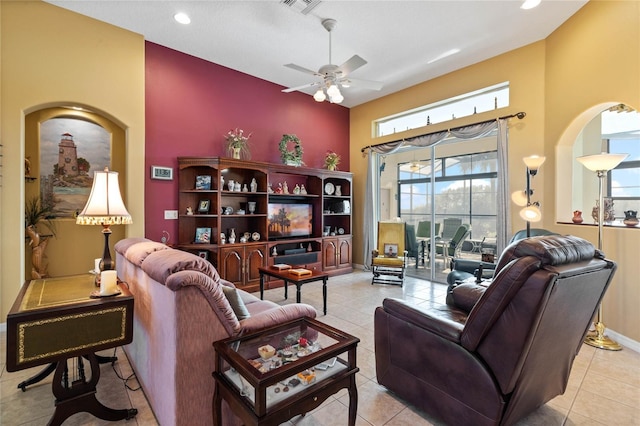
282 19 382 104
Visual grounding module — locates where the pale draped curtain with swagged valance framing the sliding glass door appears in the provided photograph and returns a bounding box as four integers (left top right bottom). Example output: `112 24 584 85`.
362 118 511 270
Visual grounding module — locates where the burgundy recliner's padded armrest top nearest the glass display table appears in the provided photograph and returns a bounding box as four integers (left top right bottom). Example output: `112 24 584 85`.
382 298 467 343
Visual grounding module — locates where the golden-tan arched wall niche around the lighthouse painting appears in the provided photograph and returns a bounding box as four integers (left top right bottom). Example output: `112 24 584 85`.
24 102 128 277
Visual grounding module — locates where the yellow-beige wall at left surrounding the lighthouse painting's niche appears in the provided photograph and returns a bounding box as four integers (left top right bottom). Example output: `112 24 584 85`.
0 1 145 321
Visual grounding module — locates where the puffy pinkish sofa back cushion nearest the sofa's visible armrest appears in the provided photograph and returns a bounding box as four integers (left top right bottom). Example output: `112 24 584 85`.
141 249 220 285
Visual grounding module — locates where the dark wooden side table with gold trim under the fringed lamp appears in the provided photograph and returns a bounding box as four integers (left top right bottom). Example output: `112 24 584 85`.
7 274 138 425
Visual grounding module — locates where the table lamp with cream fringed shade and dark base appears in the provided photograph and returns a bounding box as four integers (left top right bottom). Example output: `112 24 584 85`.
76 167 133 272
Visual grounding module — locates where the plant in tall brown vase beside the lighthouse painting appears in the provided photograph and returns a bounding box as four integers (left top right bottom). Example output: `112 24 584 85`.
24 197 56 279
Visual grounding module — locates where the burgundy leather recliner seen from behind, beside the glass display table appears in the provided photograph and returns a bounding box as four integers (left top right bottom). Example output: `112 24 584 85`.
375 235 616 426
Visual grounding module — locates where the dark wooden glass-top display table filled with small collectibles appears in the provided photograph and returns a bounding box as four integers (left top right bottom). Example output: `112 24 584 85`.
213 318 360 425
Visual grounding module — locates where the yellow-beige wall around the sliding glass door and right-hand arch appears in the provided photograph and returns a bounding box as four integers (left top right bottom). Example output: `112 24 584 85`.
351 0 640 342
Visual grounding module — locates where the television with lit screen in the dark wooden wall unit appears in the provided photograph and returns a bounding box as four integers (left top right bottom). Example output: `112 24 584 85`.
267 203 313 240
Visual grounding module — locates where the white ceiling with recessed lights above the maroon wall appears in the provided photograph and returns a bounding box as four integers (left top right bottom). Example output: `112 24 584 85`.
47 0 587 107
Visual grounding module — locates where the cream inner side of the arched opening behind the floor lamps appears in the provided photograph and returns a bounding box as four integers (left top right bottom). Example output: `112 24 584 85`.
554 102 636 222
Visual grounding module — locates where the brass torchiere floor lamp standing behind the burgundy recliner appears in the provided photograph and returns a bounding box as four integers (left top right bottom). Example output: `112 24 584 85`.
577 152 629 351
